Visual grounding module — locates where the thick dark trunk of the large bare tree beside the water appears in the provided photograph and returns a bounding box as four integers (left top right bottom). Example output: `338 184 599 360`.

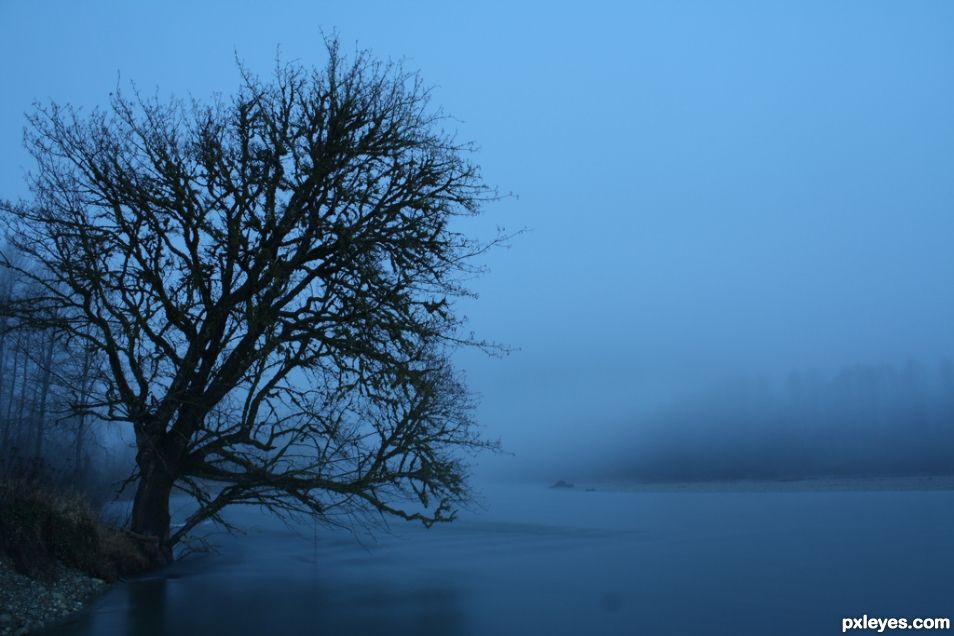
132 458 174 566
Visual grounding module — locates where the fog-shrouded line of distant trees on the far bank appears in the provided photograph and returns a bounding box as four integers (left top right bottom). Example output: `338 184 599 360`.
612 361 954 481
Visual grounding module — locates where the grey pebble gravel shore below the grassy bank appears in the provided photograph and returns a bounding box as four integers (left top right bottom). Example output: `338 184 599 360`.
0 557 108 636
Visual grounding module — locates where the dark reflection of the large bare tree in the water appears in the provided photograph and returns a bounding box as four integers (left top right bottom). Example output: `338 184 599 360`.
46 576 467 636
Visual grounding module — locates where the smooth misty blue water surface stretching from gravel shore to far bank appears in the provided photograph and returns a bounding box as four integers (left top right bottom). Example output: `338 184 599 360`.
41 485 954 636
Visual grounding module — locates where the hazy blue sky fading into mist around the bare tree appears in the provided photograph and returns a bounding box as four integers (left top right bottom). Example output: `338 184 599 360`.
0 0 954 478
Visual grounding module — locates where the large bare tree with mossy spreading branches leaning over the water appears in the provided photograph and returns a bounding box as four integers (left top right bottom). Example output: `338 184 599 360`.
3 42 499 562
